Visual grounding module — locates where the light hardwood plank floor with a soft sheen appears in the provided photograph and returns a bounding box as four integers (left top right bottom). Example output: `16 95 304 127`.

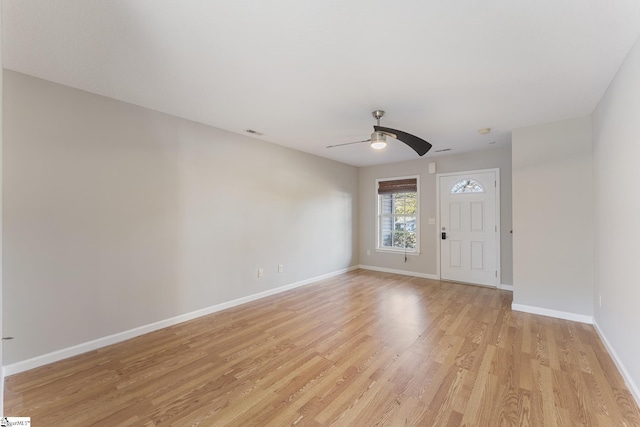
5 270 640 427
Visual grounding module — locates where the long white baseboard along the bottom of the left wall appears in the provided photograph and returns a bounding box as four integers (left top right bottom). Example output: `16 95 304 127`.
2 266 358 376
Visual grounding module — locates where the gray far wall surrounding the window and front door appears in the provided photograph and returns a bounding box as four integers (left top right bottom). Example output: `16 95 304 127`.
359 147 513 285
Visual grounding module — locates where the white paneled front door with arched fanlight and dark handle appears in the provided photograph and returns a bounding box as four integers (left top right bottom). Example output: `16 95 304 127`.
438 170 500 286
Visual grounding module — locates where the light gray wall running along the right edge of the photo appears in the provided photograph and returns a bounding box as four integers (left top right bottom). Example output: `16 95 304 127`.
593 35 640 401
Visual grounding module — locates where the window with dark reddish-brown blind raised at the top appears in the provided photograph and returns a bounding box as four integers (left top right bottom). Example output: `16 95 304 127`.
377 176 419 252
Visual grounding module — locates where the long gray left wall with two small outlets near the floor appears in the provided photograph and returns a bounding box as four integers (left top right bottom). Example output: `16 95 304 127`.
3 71 358 364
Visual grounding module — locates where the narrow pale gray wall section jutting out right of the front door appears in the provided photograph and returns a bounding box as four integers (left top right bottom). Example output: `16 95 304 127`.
512 116 593 316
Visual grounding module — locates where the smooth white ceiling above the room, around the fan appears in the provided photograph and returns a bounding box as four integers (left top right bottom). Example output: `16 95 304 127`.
2 0 640 166
